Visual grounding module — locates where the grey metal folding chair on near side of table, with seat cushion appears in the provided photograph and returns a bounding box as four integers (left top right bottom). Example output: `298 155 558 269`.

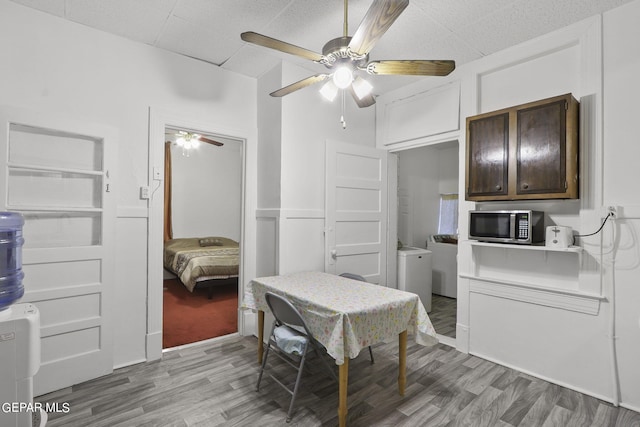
256 292 338 422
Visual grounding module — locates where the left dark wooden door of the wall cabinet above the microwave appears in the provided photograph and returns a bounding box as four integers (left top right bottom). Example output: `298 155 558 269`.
467 112 509 200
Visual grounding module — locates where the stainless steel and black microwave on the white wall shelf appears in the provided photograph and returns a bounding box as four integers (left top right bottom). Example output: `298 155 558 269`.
469 210 544 245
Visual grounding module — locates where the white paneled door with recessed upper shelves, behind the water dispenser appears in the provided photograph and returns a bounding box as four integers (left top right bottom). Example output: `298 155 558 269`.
0 108 116 396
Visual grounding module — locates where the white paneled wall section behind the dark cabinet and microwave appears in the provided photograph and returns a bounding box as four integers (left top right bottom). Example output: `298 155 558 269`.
457 13 614 406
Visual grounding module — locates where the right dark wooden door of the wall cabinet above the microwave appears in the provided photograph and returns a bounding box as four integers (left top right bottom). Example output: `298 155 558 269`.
515 100 567 195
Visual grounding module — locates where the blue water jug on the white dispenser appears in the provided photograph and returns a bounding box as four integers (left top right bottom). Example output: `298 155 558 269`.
0 212 24 311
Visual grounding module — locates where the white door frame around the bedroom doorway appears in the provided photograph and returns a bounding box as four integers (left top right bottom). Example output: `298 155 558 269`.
146 107 257 361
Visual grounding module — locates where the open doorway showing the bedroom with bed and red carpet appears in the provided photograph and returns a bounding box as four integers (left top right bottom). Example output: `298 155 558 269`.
162 127 242 349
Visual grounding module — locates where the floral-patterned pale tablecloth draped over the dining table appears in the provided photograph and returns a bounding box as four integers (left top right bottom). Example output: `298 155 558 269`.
243 271 438 365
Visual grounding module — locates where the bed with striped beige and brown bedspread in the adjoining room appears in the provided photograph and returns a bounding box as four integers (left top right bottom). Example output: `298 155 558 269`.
164 237 240 298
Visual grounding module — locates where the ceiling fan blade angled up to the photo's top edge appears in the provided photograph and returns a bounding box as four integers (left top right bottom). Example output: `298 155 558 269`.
349 0 409 55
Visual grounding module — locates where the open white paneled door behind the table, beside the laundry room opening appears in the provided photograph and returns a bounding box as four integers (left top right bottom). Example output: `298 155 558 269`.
325 141 388 285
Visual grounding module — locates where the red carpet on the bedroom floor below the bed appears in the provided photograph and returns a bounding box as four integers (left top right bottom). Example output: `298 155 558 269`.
162 279 238 348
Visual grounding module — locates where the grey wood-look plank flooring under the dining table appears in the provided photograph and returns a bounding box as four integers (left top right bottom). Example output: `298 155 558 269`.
36 336 640 427
